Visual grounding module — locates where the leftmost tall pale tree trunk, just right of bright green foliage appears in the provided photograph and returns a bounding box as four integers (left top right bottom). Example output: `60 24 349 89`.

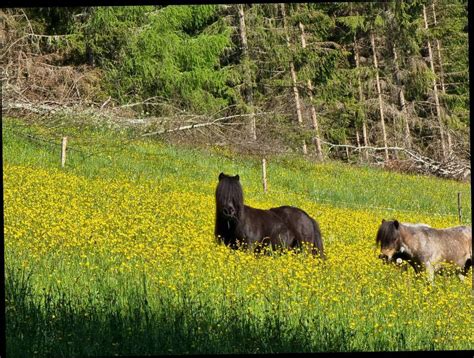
237 4 257 140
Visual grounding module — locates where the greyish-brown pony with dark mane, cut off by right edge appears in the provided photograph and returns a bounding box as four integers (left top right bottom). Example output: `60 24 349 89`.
375 220 472 281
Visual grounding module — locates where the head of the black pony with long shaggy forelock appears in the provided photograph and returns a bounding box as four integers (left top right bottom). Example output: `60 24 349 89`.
216 173 244 219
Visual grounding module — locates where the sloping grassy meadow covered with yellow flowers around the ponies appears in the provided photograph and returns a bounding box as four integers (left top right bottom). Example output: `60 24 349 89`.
2 118 474 357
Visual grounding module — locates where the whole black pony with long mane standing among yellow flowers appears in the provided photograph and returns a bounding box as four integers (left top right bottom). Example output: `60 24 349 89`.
214 173 324 258
